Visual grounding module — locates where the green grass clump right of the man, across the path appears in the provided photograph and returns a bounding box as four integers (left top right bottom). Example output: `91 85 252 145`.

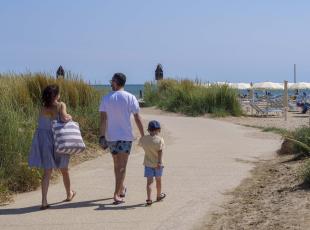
144 79 242 117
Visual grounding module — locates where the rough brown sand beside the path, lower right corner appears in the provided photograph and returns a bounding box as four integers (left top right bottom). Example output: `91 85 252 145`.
197 156 310 230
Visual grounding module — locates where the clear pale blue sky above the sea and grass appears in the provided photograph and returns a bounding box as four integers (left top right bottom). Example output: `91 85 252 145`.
0 0 310 83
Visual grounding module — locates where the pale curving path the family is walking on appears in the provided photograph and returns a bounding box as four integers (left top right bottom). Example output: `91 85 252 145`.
0 114 280 230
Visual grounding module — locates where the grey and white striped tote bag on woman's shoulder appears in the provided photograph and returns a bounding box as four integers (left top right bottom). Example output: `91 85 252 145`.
52 120 86 155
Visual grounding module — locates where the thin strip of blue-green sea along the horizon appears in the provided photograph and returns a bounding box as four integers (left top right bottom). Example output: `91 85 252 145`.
92 84 310 98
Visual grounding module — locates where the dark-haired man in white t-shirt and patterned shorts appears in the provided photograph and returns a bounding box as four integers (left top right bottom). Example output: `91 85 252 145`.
99 73 144 204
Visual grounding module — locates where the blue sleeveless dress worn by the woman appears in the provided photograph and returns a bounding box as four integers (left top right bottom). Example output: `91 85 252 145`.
28 115 70 169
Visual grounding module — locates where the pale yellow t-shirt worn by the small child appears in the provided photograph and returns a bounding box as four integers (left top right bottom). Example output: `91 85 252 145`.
140 135 165 168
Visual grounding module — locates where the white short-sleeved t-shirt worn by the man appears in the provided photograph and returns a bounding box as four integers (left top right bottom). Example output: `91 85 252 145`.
99 90 140 141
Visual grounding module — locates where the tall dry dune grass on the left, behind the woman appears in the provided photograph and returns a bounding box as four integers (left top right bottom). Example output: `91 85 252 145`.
0 73 100 201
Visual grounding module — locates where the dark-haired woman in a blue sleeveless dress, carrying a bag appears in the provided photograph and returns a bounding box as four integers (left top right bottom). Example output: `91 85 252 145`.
28 85 76 210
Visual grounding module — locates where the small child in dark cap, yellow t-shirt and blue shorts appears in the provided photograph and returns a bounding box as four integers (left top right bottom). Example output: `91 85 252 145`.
140 121 166 205
